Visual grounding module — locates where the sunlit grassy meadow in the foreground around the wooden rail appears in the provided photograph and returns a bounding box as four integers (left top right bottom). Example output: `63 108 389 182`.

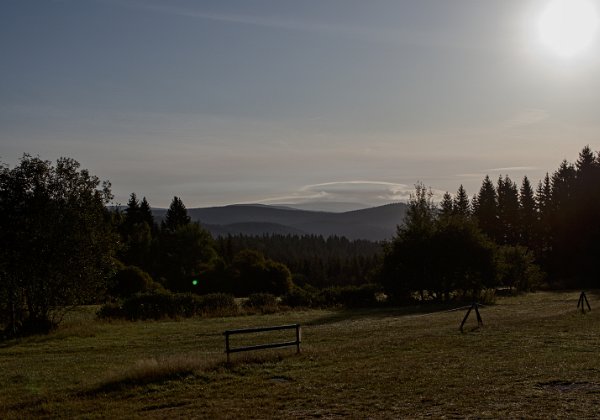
0 292 600 418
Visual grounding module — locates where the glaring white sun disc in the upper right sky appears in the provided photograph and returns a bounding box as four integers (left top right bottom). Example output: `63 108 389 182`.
538 0 598 58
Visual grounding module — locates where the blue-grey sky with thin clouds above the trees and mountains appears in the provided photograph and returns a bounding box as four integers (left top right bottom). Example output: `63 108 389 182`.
0 0 600 208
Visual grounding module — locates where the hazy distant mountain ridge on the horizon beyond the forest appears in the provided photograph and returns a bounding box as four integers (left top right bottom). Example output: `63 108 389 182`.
153 203 406 241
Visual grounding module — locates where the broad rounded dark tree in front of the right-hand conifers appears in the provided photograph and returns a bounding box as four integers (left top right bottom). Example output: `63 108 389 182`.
380 186 495 302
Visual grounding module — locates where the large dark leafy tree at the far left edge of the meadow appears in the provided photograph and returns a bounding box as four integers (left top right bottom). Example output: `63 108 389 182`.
0 155 117 333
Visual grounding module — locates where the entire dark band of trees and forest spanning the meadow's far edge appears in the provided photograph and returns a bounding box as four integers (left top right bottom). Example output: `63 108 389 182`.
0 147 600 334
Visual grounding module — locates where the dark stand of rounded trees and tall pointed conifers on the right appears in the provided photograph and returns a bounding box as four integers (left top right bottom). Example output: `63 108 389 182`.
380 146 600 300
